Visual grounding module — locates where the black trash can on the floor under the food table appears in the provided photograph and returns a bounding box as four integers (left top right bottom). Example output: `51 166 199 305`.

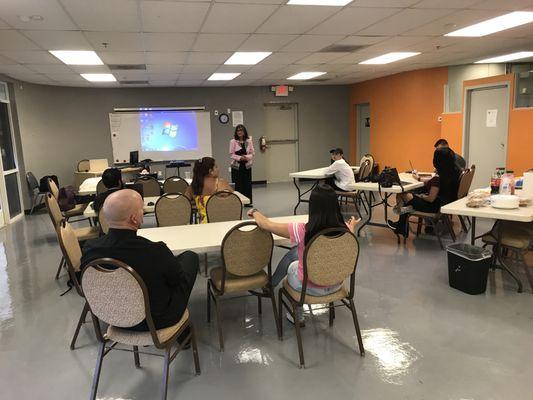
446 243 492 294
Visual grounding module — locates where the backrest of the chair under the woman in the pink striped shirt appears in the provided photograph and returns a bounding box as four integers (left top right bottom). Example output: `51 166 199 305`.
302 228 359 295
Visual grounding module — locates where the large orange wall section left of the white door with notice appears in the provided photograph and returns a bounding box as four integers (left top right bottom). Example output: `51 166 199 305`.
350 67 448 171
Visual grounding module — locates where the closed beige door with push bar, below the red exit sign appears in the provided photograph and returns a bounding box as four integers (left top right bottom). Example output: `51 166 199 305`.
264 104 298 182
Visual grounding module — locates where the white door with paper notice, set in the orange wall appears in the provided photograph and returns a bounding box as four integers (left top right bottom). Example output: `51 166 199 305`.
464 85 509 189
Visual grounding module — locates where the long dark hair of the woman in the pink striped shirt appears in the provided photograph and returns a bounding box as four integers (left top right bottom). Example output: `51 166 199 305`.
304 183 346 244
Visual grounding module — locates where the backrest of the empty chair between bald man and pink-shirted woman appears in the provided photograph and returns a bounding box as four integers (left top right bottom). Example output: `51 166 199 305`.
221 221 274 277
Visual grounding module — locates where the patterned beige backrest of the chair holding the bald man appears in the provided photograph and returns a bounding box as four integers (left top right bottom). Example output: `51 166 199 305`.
81 258 146 328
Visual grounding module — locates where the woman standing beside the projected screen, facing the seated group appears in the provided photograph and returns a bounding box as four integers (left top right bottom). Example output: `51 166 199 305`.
229 125 255 207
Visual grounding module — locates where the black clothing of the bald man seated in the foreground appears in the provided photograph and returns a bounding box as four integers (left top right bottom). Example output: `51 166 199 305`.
81 229 194 329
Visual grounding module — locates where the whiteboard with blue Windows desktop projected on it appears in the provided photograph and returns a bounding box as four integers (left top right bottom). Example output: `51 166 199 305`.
109 110 212 163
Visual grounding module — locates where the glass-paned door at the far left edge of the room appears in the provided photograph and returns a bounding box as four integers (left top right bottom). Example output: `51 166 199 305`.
0 82 22 222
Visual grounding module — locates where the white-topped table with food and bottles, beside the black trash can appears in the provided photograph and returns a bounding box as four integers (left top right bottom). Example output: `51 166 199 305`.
440 190 533 292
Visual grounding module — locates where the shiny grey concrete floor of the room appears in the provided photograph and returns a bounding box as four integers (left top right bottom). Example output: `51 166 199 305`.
0 183 533 400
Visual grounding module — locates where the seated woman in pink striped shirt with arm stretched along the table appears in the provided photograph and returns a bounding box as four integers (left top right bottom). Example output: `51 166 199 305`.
248 184 359 322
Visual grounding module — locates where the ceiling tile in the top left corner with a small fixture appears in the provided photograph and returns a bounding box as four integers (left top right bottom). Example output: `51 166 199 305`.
0 0 76 30
